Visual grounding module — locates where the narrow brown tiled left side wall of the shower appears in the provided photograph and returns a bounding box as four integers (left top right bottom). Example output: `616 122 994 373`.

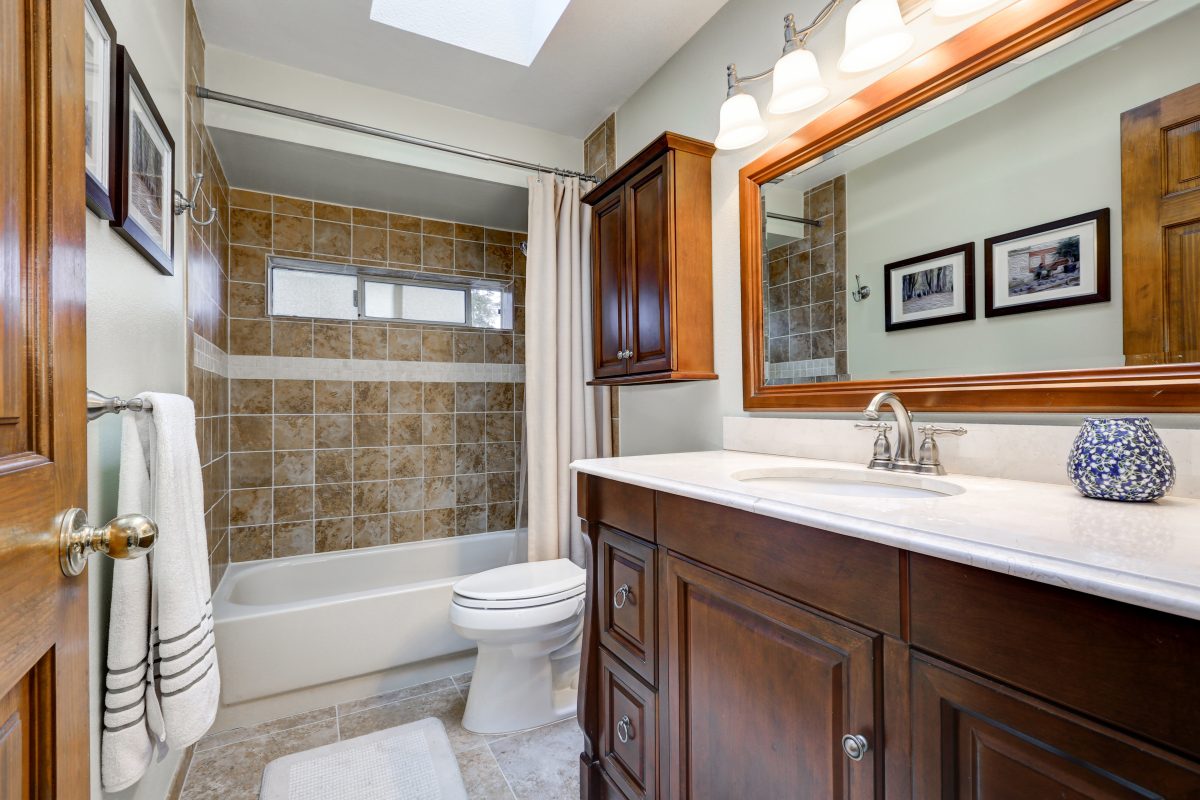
184 2 229 588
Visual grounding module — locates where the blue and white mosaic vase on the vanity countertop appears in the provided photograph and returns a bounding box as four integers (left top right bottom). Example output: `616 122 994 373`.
1067 416 1175 503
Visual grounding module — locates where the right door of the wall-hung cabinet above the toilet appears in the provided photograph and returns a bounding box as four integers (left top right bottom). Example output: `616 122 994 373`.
625 154 673 373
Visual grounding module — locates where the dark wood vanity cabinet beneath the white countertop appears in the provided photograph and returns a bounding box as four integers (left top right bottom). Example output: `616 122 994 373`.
578 475 1200 800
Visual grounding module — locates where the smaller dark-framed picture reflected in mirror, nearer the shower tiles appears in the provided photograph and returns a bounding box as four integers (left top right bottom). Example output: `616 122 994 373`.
883 242 974 331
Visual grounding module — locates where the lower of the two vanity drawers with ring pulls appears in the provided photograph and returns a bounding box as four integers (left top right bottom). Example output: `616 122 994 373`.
600 650 658 800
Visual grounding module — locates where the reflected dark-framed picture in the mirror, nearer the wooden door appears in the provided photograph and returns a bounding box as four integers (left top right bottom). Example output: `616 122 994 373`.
983 209 1111 317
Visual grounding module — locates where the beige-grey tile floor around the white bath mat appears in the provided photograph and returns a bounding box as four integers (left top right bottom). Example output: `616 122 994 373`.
181 673 583 800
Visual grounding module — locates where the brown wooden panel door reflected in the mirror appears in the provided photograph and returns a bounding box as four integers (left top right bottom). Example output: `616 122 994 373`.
1121 84 1200 365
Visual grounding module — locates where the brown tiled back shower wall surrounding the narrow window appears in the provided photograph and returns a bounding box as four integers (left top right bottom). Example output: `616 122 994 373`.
229 190 524 561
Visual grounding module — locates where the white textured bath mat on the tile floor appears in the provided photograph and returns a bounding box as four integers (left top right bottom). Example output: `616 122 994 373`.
259 717 467 800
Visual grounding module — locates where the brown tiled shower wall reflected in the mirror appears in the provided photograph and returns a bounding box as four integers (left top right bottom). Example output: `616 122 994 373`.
762 175 850 385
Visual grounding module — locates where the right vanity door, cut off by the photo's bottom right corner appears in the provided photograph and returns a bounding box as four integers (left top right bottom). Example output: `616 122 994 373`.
912 649 1200 800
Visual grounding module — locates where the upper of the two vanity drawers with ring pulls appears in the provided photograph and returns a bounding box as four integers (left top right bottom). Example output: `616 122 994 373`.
598 527 658 686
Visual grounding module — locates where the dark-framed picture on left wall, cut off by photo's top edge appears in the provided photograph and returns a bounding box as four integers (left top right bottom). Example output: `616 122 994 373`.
83 0 118 219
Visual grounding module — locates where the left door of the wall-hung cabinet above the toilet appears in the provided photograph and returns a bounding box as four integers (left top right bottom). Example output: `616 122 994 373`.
592 188 629 378
